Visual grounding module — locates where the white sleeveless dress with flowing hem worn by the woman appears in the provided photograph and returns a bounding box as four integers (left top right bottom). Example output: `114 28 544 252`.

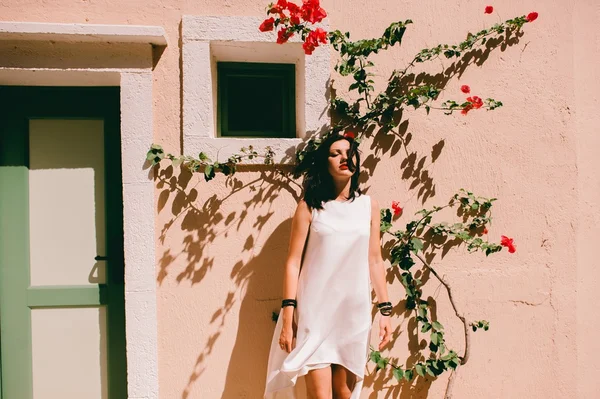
264 195 372 399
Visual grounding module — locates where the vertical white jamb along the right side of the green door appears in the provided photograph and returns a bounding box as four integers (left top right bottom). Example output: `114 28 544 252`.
121 72 158 399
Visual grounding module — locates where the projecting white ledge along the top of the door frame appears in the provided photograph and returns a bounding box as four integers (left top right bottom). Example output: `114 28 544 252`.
0 21 167 46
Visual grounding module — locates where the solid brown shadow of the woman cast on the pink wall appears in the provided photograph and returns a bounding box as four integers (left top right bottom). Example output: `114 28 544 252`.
221 219 312 399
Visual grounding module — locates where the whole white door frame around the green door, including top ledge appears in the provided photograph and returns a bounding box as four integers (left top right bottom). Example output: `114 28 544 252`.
0 21 167 399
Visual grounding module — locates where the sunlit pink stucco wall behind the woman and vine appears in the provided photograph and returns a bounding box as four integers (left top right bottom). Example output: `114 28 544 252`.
0 0 600 399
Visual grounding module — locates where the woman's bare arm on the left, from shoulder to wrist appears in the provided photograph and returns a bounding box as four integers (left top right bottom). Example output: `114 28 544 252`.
282 200 311 326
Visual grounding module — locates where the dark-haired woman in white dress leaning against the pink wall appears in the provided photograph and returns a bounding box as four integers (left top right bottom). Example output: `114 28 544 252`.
265 133 392 399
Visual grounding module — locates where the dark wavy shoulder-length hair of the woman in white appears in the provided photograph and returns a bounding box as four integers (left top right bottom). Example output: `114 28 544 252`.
295 134 362 209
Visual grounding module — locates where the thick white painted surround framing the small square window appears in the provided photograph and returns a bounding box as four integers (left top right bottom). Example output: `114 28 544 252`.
182 15 330 164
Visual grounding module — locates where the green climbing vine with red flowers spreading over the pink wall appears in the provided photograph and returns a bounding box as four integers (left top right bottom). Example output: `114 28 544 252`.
147 0 538 398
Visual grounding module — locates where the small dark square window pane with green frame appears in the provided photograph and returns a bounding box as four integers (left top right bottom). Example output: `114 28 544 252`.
217 62 296 138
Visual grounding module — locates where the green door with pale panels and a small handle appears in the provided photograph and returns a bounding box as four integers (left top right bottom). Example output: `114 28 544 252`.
0 86 127 399
